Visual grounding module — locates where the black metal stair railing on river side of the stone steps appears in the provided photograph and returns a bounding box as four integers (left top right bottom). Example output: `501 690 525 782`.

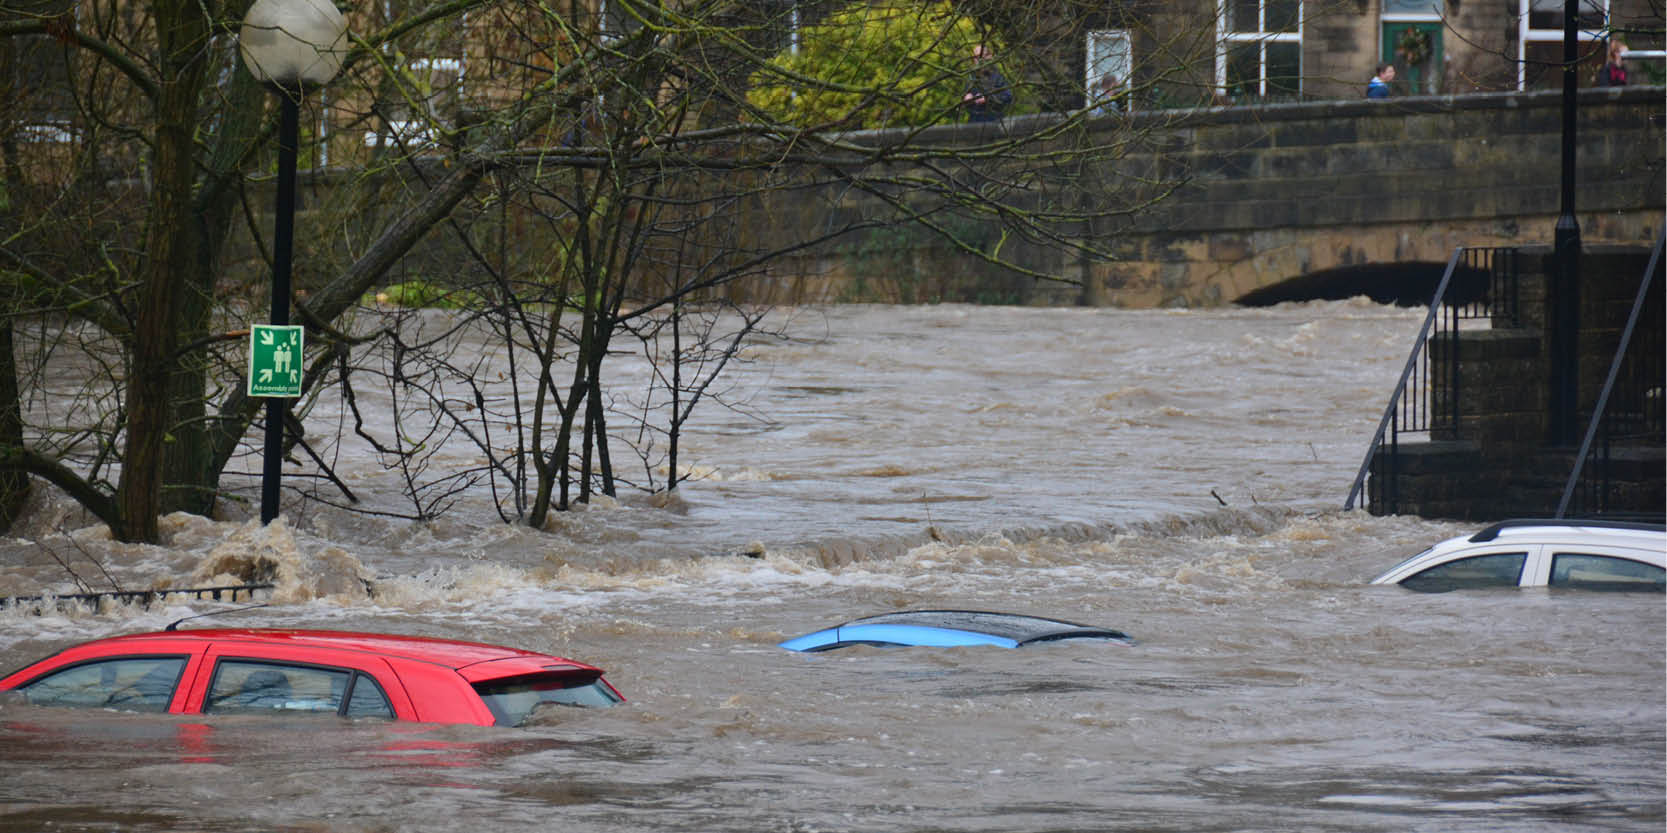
1344 247 1522 515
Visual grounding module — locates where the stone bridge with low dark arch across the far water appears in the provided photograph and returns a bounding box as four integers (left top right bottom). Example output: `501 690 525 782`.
737 87 1664 307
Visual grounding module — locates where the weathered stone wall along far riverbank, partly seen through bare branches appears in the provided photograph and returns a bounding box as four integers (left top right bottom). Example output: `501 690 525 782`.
266 87 1667 308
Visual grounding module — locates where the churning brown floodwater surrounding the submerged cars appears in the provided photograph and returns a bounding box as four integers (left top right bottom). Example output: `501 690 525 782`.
0 302 1667 833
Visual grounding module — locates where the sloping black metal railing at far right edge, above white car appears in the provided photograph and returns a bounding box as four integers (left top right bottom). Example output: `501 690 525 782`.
1557 232 1667 518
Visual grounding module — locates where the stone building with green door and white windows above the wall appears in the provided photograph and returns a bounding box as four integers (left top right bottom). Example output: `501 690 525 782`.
1055 0 1662 107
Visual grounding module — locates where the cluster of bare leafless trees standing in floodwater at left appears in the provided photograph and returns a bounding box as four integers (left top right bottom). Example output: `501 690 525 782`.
0 0 1209 540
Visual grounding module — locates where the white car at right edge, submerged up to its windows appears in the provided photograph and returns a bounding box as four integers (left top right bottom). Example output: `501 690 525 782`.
1372 520 1667 593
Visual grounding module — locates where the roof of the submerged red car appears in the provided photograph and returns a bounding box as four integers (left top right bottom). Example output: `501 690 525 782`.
95 628 593 671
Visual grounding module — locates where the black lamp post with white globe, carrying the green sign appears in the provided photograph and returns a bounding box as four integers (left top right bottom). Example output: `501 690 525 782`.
238 0 347 523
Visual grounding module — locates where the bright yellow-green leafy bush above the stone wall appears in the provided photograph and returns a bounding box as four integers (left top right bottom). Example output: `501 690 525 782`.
747 0 1017 128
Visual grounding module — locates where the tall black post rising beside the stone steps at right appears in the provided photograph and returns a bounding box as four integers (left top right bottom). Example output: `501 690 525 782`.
1547 0 1582 445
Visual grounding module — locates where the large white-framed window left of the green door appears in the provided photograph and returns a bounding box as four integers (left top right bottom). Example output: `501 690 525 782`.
1215 0 1302 100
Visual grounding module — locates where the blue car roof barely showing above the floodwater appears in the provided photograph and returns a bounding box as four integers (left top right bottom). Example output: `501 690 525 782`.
780 610 1134 651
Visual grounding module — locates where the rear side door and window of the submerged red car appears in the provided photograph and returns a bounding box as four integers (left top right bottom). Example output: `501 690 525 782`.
185 640 415 720
